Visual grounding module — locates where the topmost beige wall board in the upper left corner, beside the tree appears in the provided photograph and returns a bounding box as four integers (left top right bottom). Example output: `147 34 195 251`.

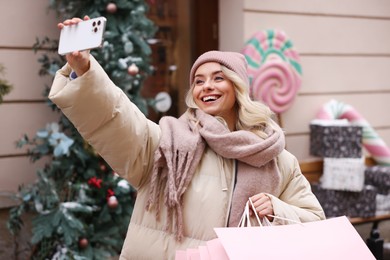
0 0 59 48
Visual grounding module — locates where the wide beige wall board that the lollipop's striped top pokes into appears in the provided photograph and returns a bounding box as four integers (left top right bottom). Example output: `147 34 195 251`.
243 12 390 55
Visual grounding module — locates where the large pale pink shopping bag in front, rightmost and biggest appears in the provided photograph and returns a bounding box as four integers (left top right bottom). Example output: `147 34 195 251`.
215 216 375 260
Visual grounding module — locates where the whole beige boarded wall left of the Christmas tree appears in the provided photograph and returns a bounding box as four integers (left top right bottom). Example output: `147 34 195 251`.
0 0 58 194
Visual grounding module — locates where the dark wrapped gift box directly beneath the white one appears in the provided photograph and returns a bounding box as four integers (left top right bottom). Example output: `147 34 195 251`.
312 184 377 218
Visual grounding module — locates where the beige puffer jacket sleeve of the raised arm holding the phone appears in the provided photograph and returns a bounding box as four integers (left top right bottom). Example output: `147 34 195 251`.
49 55 160 188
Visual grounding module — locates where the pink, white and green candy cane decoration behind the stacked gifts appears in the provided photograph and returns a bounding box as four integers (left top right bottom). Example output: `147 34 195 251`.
316 100 390 166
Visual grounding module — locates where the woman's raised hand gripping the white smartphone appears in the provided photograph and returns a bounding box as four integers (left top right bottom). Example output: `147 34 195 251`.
57 16 90 76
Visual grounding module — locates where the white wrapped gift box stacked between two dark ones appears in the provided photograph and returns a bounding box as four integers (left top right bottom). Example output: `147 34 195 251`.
320 157 365 192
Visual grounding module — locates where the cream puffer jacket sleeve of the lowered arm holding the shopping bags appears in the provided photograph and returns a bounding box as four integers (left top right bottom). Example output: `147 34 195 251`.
268 151 325 224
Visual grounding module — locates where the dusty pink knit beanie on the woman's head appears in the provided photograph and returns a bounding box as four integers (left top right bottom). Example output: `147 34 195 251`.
190 51 249 87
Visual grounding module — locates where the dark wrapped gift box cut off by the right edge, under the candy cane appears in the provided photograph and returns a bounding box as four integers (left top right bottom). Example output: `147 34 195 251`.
364 165 390 195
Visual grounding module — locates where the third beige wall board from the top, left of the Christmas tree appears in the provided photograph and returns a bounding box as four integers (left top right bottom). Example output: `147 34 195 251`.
0 103 59 155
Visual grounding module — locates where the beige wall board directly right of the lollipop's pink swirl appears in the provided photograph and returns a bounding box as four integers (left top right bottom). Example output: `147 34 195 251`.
299 56 390 94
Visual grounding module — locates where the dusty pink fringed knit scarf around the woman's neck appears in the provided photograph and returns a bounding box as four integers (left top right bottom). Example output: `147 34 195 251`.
146 109 285 241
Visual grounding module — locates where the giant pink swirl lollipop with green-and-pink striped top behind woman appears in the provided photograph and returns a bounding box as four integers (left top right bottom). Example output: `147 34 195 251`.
242 30 302 114
